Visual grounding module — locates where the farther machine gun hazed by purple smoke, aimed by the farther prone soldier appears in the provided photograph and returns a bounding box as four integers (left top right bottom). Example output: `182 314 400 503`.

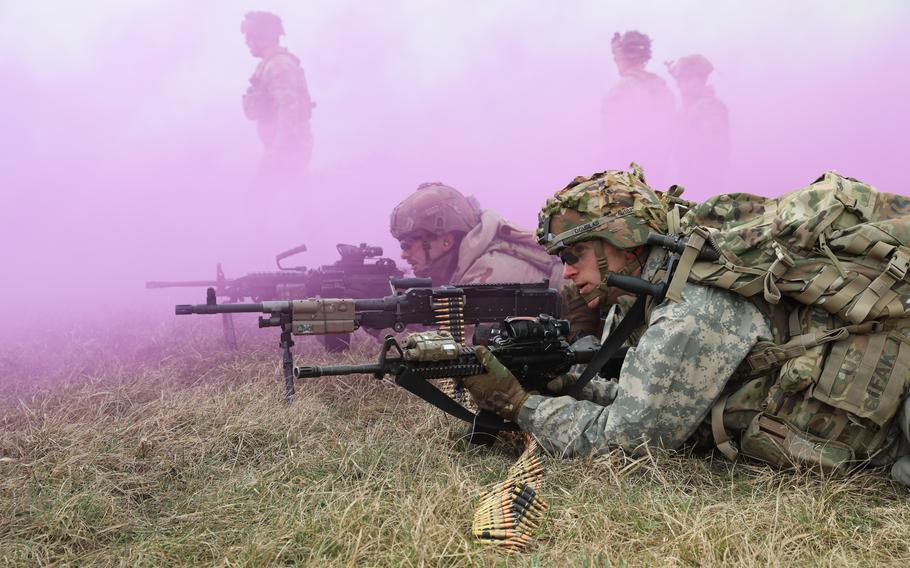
145 243 404 353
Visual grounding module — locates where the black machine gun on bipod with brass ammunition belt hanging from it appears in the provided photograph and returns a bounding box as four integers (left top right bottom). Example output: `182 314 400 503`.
175 278 559 399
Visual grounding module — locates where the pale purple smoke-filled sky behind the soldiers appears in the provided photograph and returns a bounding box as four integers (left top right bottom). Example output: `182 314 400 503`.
0 0 910 327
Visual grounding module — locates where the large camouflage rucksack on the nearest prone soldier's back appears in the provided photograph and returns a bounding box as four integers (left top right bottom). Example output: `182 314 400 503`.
668 172 910 471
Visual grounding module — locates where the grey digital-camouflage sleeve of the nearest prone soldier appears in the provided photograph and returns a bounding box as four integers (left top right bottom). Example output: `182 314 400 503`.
518 272 771 457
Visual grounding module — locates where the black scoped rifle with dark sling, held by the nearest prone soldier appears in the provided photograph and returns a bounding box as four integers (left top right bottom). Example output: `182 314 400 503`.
294 315 625 442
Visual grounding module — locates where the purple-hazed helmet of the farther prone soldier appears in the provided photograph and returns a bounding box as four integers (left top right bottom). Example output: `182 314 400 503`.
389 182 480 240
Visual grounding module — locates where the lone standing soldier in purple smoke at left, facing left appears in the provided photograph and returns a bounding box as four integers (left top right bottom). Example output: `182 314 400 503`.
240 12 315 189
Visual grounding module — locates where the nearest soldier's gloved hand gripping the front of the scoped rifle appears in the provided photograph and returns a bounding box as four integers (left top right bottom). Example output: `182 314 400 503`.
464 346 530 422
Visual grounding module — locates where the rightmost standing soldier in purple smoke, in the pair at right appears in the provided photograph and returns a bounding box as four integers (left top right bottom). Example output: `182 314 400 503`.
667 54 730 194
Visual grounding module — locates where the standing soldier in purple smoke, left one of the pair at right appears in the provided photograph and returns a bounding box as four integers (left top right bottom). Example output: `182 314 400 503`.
601 31 676 186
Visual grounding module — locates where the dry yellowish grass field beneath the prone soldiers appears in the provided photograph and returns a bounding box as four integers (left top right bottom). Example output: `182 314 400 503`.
0 318 910 566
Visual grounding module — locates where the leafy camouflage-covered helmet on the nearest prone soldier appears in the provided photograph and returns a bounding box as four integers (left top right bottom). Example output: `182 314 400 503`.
537 164 667 254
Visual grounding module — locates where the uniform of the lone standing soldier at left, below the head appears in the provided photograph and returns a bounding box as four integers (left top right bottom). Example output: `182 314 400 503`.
243 48 313 173
